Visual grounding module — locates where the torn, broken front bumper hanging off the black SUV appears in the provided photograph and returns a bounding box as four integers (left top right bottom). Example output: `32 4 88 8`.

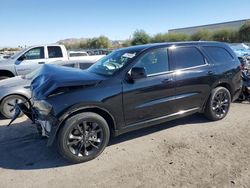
8 103 58 146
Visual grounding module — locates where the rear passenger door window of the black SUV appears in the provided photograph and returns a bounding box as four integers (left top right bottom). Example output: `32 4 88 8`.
171 47 205 69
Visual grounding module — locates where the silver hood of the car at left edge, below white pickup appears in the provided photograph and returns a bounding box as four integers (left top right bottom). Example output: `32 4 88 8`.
0 76 31 89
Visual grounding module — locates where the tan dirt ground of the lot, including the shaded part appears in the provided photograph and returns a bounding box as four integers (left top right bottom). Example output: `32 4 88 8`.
0 104 250 188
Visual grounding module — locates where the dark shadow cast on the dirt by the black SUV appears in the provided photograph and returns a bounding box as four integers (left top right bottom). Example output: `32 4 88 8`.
0 115 207 170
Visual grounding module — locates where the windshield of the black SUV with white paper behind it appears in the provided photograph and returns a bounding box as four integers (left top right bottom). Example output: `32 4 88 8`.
88 49 138 76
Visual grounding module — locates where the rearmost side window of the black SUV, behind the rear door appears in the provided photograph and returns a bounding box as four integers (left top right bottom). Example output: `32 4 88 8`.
204 46 233 62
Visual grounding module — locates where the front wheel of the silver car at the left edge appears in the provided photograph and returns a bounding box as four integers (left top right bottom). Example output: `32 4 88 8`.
0 95 29 119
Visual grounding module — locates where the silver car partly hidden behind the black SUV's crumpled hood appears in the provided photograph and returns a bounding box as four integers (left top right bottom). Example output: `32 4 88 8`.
0 60 94 118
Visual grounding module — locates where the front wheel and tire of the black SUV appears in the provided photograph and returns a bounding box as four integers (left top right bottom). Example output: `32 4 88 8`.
57 112 110 163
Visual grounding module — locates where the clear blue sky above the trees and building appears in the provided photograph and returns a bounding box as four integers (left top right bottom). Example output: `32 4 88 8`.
0 0 250 47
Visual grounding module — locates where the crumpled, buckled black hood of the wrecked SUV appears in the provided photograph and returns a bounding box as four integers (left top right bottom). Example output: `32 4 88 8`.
31 65 105 100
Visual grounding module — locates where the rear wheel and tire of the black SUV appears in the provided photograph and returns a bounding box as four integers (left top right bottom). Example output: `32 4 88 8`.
204 87 231 121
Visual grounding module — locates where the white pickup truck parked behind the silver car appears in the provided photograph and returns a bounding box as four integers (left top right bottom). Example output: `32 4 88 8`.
0 44 103 80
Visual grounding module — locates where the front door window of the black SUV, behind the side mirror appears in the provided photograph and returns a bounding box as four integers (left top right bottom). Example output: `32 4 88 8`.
135 48 169 75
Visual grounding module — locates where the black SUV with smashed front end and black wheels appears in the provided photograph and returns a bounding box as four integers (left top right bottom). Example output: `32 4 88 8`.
14 42 241 163
